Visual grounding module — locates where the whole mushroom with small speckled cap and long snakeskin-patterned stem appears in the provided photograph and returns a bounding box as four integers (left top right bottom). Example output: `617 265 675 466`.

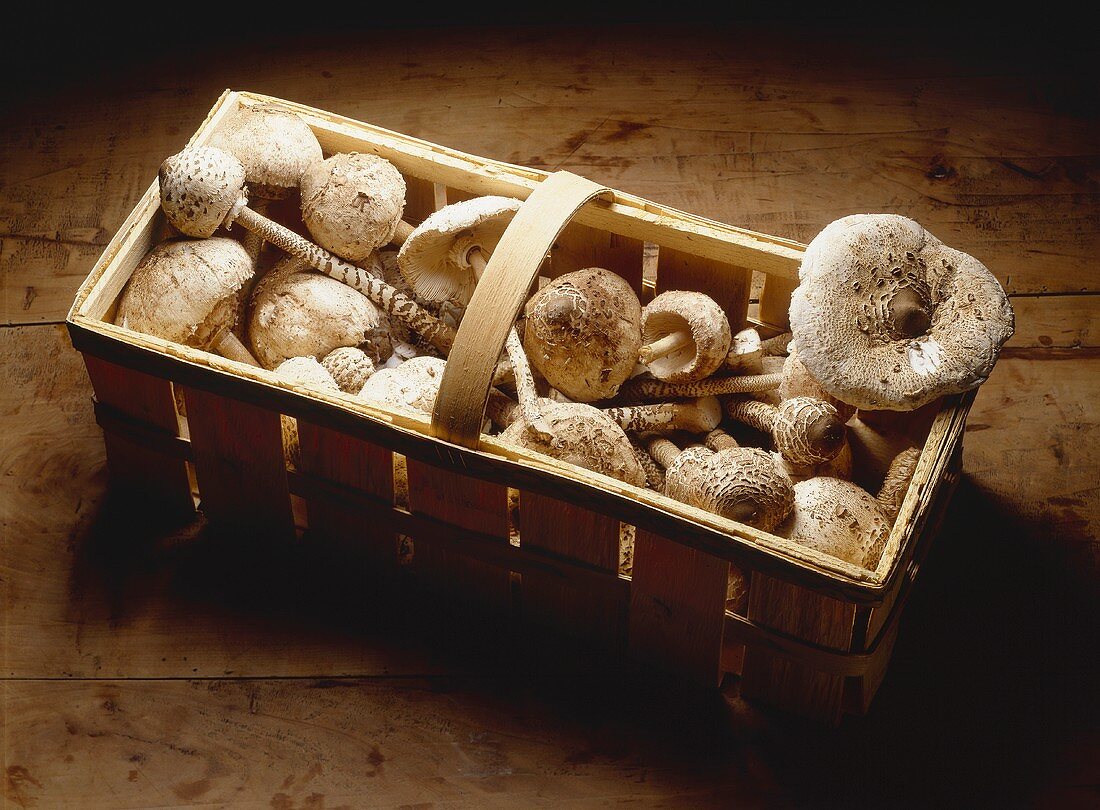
160 146 455 353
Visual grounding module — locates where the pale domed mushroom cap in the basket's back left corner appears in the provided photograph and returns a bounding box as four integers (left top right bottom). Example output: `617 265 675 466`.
210 103 323 199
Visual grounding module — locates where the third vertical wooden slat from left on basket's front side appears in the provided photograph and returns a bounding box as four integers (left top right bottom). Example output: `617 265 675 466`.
298 419 397 569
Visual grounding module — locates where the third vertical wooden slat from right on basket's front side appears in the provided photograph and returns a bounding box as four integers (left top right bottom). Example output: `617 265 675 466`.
519 492 627 652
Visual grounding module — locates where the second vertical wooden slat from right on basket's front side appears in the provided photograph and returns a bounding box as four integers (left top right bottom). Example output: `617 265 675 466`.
628 529 729 688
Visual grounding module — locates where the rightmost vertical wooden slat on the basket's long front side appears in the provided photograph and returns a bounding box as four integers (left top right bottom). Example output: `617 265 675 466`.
741 572 856 724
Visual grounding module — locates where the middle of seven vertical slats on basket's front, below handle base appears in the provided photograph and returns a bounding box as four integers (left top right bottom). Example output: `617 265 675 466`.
406 459 512 615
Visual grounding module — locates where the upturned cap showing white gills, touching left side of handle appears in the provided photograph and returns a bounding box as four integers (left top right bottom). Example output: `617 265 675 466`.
397 196 523 304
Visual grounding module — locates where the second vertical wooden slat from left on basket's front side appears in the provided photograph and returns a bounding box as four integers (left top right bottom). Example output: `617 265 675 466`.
184 386 295 545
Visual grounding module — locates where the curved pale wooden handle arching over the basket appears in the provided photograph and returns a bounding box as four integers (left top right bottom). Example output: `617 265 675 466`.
431 172 612 449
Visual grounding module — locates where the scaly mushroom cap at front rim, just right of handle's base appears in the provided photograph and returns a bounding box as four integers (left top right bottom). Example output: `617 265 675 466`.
497 398 646 486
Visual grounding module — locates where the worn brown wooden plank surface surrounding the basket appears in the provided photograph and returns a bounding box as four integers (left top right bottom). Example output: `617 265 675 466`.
0 26 1100 810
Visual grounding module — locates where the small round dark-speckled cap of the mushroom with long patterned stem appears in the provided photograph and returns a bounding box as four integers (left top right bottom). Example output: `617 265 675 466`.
160 146 248 237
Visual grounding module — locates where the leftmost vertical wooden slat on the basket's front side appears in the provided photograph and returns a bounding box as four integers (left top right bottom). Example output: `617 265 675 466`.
85 354 195 516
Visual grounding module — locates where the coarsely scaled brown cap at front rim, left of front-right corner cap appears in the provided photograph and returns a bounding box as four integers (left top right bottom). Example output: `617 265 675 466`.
664 447 794 532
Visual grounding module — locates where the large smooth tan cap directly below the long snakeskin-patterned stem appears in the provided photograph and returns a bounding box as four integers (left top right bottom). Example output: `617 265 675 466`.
249 256 388 369
